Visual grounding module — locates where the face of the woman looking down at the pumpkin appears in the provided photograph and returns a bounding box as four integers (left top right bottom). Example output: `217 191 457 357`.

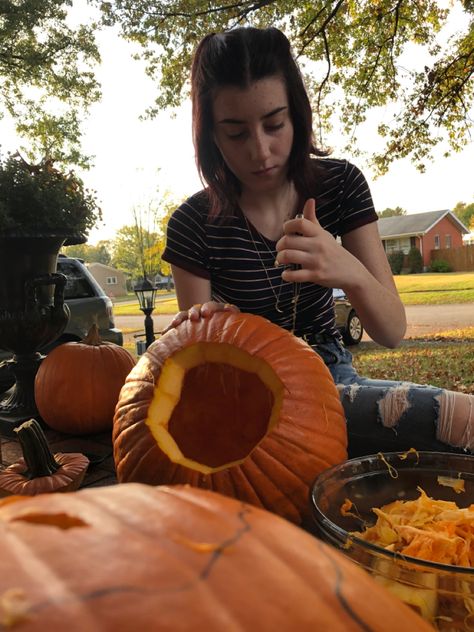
213 76 293 191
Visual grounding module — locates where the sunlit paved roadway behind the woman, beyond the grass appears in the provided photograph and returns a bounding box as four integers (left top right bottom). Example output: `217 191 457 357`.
115 303 474 340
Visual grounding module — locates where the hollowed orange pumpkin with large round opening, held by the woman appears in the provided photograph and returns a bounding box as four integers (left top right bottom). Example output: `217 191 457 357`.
113 312 347 523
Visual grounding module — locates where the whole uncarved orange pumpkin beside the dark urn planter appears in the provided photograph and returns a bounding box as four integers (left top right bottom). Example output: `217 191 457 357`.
35 324 135 435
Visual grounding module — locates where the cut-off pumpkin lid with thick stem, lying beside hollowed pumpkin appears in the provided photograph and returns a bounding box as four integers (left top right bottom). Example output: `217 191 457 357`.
0 419 89 497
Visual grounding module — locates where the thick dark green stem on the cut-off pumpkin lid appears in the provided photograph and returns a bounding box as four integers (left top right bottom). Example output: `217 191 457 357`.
14 419 61 479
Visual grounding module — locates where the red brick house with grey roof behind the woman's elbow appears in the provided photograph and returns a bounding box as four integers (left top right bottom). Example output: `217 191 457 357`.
378 210 469 268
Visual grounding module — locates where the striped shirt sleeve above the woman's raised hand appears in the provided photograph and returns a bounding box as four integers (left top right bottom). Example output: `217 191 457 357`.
339 162 378 235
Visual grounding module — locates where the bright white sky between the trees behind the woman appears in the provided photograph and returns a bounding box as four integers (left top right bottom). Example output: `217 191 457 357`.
0 1 474 244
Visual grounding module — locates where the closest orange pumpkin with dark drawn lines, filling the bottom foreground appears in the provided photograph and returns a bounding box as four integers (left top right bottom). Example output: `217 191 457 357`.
0 484 432 632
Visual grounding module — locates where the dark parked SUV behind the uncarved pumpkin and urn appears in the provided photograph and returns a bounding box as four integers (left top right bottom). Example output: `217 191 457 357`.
0 255 123 392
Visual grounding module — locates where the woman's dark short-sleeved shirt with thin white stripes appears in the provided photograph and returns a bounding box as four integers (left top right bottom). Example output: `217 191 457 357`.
162 158 377 341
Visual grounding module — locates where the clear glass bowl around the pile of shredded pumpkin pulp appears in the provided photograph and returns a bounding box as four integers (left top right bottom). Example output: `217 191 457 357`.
310 452 474 632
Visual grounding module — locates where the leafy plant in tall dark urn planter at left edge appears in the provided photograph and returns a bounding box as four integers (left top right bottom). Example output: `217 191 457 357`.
0 153 102 436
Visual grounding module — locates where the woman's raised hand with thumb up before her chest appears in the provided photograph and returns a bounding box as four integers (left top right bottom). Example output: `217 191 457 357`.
276 199 362 288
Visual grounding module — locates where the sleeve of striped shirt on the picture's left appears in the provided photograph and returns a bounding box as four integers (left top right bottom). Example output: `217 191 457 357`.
161 198 211 279
